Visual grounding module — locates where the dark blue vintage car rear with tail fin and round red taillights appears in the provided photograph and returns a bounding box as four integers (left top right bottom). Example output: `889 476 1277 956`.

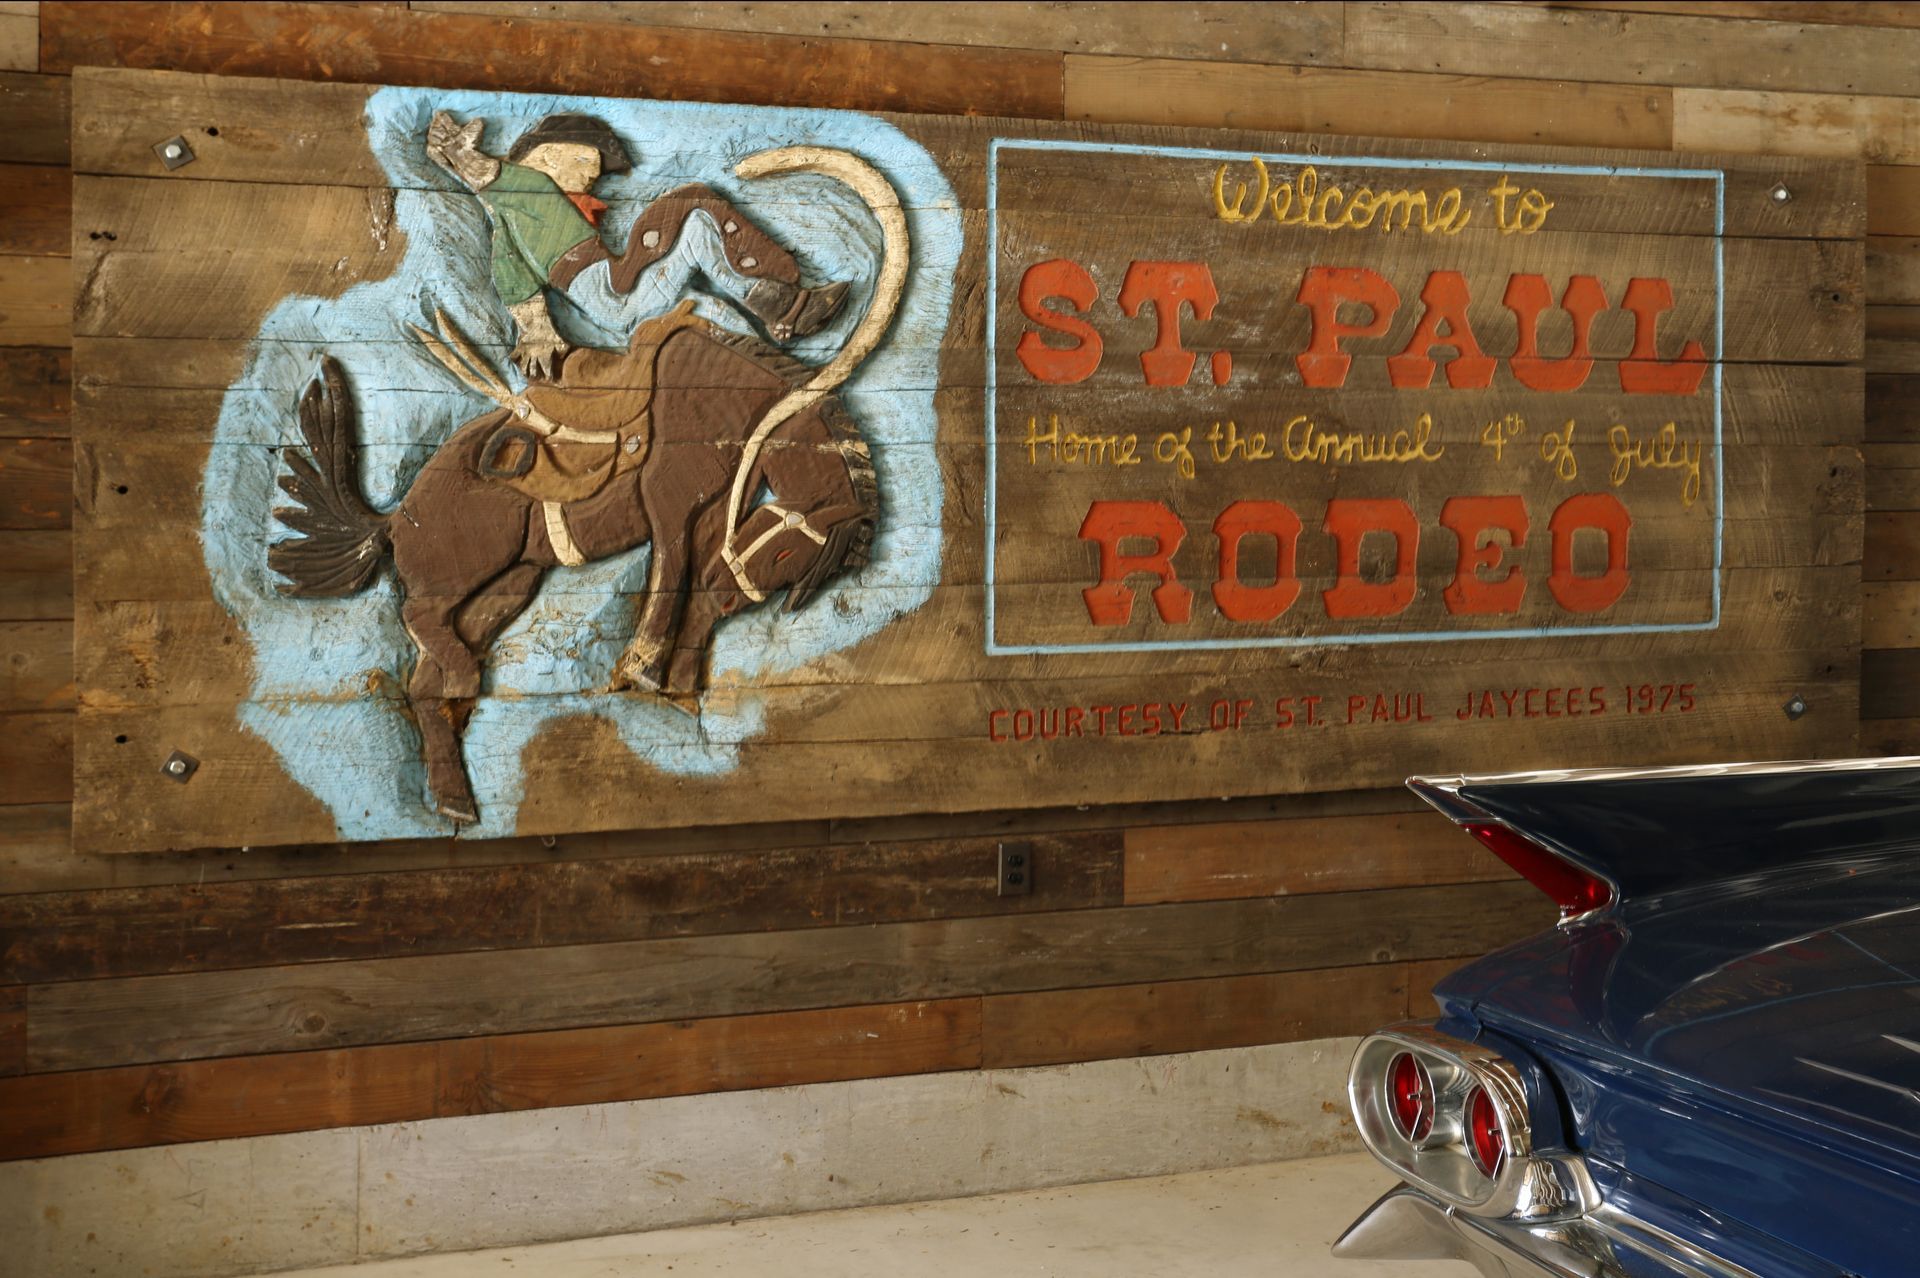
1334 758 1920 1278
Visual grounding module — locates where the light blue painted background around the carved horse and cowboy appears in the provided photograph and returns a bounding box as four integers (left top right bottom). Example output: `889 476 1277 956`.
202 88 962 839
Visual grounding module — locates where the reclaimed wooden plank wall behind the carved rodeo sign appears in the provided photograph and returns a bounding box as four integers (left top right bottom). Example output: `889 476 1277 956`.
0 0 1896 1157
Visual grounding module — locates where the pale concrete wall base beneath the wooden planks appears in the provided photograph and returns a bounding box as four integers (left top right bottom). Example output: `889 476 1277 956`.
0 1038 1357 1278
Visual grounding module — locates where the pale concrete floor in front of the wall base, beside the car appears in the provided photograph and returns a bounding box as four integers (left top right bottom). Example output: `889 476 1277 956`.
282 1155 1473 1278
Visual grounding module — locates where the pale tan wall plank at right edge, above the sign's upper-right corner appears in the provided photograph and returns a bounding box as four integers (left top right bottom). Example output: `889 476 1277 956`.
1672 88 1920 165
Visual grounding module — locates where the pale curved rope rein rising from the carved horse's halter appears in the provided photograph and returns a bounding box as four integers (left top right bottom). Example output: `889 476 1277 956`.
726 146 908 556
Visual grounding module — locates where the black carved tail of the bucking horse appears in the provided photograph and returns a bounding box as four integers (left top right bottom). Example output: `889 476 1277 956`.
267 359 392 599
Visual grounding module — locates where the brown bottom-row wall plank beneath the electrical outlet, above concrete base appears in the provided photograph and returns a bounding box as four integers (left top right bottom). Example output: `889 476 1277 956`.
981 955 1413 1069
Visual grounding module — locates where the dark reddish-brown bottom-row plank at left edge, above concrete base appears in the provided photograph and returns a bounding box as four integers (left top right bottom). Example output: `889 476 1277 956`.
0 1042 436 1159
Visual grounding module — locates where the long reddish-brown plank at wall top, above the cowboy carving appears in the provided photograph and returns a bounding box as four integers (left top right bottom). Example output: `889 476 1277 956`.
40 2 1060 119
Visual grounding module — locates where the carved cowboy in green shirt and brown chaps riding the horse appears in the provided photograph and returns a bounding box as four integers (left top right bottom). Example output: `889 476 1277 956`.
426 111 847 378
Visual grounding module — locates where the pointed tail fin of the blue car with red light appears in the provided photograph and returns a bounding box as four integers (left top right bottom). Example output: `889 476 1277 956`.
1407 758 1920 921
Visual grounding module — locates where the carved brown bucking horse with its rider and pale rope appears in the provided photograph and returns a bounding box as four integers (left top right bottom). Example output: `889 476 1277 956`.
267 117 908 823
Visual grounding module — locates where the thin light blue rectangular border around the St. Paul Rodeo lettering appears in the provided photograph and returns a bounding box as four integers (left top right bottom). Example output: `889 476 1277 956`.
987 138 1726 656
